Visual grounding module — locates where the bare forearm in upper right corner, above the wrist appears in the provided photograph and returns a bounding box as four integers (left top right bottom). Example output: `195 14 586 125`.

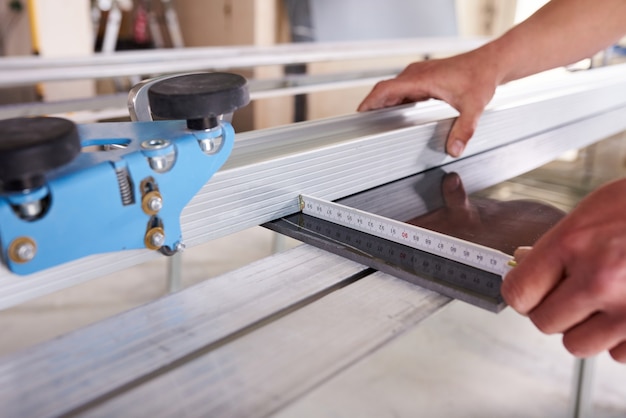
480 0 626 84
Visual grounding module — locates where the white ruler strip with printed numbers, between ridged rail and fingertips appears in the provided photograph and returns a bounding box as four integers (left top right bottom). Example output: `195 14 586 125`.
300 195 514 277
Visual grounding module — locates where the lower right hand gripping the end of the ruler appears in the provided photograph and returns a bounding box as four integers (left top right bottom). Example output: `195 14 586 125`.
501 179 626 363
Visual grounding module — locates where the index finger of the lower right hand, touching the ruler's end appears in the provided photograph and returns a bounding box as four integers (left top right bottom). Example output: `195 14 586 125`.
500 232 564 315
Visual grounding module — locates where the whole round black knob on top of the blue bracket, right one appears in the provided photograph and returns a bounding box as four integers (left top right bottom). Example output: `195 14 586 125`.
148 73 250 129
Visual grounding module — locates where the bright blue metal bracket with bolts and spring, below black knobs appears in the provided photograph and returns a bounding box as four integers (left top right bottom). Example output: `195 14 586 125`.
0 120 235 274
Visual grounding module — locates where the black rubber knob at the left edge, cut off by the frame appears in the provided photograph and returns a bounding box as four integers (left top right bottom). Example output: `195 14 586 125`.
0 117 81 192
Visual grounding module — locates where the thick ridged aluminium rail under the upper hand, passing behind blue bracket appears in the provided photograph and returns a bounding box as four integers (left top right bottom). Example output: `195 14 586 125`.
0 66 626 308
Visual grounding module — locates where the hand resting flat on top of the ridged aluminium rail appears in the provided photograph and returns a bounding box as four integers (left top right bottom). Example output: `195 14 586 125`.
357 49 500 157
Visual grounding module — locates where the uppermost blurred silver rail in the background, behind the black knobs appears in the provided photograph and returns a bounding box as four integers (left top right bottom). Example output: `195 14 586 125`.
0 37 486 87
